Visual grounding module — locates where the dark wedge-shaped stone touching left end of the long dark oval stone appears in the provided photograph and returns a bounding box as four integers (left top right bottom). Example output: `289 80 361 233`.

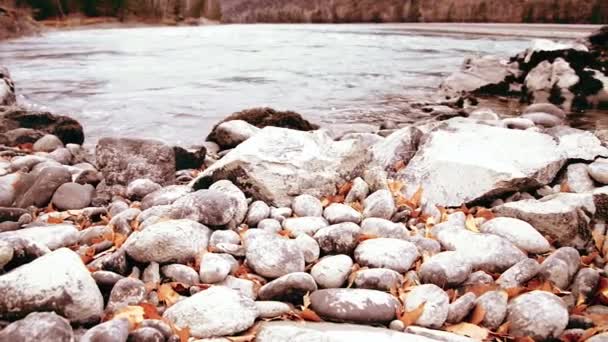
258 272 317 301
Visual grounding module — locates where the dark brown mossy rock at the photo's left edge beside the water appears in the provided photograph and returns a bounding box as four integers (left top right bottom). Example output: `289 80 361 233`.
0 106 84 145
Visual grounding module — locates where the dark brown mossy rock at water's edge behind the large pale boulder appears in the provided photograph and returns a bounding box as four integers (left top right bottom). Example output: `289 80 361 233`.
207 107 319 141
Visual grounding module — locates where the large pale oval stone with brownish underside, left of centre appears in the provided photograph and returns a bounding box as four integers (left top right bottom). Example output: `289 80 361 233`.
123 220 211 263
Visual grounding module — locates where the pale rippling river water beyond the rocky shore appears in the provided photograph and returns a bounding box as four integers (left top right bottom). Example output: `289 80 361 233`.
0 25 600 145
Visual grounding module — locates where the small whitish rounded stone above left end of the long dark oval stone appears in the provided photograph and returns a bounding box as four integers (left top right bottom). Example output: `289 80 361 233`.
310 254 353 289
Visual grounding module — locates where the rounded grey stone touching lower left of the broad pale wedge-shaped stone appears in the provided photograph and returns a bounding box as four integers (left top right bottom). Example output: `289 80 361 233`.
420 251 472 288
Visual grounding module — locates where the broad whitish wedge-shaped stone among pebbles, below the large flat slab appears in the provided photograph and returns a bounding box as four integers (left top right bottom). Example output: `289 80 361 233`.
433 226 526 272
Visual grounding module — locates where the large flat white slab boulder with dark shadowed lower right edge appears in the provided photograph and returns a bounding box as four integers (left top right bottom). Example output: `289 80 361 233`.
397 118 566 207
